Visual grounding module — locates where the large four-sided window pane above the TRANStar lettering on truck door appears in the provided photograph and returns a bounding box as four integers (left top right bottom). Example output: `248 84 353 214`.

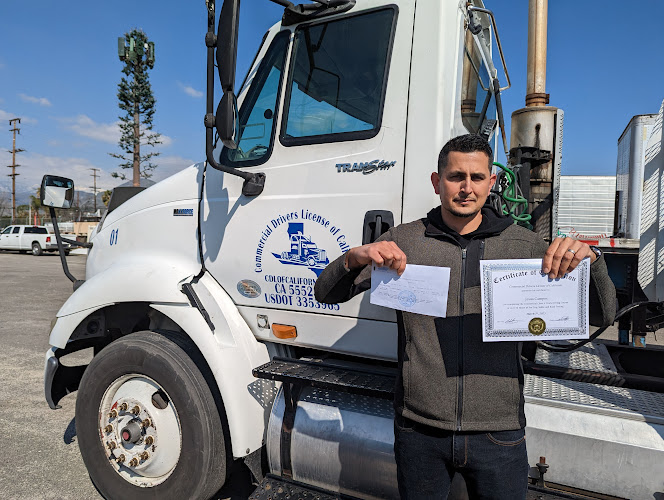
280 8 397 146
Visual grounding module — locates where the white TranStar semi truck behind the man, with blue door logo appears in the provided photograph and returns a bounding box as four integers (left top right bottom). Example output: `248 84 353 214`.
44 0 664 499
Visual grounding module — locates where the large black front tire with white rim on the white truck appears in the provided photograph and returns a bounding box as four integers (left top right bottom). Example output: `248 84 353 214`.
76 332 231 500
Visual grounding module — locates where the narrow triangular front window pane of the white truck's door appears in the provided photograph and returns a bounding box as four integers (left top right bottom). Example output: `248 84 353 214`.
220 31 290 167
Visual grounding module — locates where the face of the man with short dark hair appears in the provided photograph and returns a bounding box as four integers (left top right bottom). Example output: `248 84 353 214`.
431 151 496 219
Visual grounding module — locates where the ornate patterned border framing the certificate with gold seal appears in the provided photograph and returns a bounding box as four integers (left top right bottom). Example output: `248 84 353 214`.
482 259 590 340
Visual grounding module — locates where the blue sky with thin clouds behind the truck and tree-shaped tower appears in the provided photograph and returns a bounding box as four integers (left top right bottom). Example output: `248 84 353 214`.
0 0 664 198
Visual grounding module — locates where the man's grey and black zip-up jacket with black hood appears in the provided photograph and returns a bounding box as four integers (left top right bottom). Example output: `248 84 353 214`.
315 207 615 431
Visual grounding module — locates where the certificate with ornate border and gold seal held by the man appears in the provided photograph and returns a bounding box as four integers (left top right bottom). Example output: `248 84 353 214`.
480 259 590 342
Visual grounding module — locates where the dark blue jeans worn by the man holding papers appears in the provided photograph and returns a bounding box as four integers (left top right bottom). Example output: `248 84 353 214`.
394 416 528 500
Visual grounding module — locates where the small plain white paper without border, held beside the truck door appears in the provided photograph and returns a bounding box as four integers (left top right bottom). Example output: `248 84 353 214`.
371 264 450 318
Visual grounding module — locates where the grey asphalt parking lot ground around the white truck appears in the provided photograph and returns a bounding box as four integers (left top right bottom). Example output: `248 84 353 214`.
0 251 664 500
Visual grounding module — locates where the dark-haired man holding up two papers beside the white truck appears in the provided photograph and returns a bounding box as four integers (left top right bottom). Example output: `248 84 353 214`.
315 135 615 500
